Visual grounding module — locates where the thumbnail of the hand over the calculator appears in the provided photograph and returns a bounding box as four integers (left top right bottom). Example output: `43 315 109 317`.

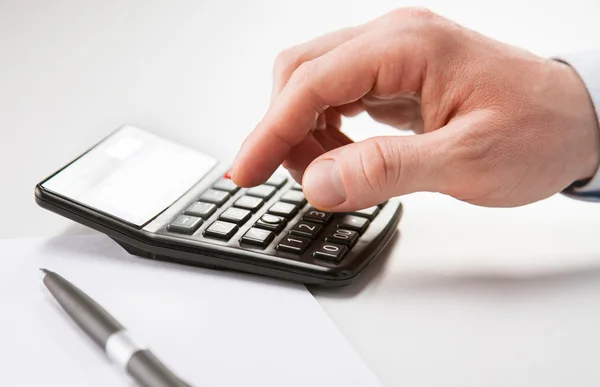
302 160 346 208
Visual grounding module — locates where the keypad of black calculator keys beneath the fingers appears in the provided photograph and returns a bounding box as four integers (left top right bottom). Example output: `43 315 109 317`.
167 174 382 265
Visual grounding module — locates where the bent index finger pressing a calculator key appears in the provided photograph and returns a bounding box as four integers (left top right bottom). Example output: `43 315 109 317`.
233 35 380 187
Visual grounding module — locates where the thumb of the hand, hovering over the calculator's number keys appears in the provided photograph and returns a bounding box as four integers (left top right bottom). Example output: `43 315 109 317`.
302 131 446 211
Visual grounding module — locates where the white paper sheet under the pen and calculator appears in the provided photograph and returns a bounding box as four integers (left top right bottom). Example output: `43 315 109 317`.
0 235 380 387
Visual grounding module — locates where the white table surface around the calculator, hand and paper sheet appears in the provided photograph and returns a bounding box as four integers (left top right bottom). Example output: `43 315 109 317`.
0 0 600 387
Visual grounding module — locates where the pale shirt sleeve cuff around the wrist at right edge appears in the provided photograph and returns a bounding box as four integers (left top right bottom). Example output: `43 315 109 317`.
554 49 600 202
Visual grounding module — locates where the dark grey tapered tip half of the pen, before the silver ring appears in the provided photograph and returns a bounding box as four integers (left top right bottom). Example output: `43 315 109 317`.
44 273 123 348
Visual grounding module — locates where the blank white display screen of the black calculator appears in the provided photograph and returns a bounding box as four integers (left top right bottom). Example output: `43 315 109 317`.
42 126 217 226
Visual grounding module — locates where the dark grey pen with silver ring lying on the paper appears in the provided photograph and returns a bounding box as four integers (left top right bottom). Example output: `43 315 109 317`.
40 269 189 387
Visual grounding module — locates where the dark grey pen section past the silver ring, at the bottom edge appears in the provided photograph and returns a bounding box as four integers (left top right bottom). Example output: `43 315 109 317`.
127 350 189 387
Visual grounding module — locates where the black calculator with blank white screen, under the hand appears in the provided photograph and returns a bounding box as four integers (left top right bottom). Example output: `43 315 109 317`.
35 125 402 286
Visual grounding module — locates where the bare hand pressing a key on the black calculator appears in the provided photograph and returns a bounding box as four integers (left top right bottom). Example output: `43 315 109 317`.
233 9 600 211
